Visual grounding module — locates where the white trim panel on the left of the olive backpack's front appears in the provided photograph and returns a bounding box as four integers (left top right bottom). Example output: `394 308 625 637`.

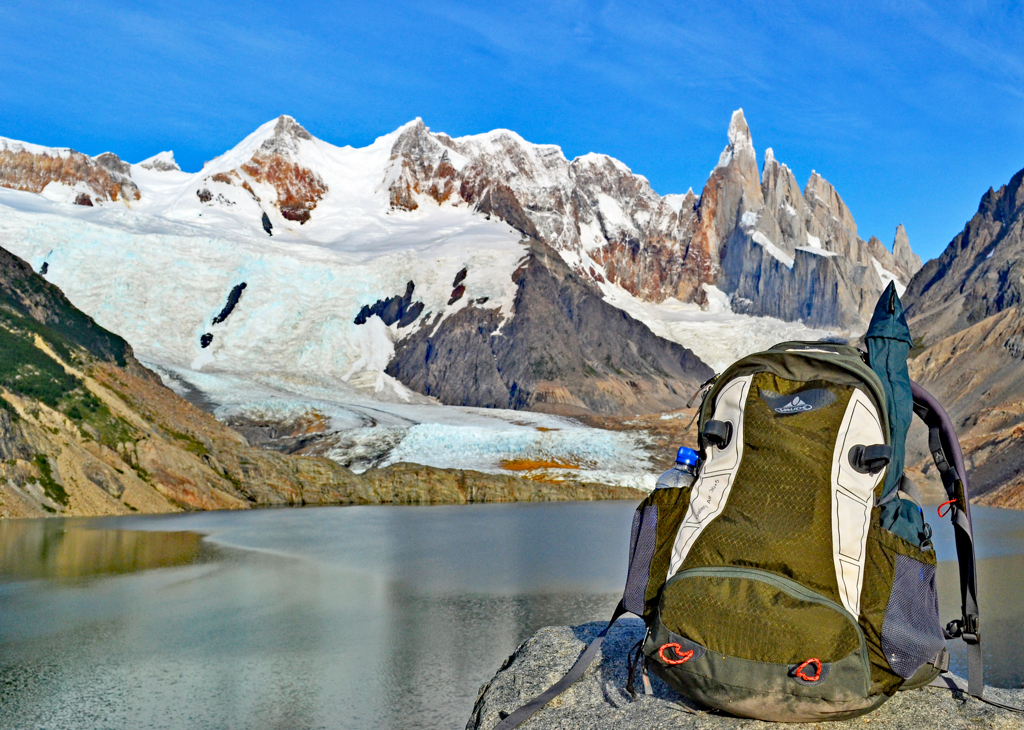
669 375 754 577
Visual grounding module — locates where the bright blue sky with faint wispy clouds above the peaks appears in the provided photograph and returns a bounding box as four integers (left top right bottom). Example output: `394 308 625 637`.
0 0 1024 259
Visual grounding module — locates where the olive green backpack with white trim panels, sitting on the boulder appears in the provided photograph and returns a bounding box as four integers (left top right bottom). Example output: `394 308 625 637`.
497 285 1012 730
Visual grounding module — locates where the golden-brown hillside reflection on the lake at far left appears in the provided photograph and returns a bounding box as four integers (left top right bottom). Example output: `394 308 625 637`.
0 519 210 579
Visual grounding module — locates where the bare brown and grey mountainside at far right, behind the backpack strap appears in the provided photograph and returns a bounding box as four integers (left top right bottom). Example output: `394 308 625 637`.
904 164 1024 509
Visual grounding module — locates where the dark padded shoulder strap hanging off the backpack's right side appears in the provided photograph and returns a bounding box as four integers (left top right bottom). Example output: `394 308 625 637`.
910 381 985 699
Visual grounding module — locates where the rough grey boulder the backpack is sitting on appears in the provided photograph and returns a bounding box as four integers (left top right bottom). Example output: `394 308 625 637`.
466 619 1024 730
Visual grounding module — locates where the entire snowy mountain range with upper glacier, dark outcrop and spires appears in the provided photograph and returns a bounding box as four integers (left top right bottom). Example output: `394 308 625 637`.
0 112 914 413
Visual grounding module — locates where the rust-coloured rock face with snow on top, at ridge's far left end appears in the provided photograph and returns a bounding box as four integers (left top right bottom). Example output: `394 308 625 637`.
0 143 140 205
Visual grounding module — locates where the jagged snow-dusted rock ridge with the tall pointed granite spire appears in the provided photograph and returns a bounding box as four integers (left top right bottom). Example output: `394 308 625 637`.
376 110 921 330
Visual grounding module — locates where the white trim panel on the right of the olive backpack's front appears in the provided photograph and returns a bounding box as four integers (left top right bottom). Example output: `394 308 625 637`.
831 389 886 616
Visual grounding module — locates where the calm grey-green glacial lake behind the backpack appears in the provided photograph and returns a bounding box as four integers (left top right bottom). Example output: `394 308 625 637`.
0 502 1024 730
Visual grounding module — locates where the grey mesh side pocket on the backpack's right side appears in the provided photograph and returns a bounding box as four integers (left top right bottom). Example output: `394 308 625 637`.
882 555 946 679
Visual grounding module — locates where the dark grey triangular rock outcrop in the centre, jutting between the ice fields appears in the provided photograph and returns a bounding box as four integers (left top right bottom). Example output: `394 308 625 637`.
387 236 712 414
